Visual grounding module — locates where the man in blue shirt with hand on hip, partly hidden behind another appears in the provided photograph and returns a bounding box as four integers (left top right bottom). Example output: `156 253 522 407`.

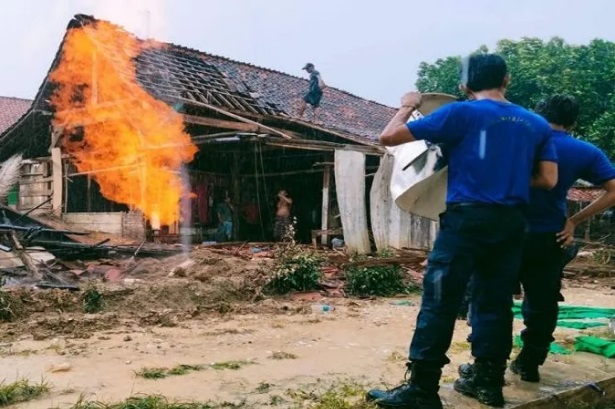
459 95 615 382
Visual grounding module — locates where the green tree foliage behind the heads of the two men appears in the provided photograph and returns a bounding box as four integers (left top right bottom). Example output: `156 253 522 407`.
416 37 615 159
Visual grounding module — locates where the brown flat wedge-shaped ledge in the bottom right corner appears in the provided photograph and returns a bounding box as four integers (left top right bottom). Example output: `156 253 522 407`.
514 376 615 409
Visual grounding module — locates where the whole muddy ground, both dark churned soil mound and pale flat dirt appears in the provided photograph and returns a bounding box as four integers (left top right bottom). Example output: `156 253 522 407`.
0 247 615 408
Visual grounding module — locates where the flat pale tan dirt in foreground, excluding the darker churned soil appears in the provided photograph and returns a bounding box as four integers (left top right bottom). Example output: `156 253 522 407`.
0 280 615 408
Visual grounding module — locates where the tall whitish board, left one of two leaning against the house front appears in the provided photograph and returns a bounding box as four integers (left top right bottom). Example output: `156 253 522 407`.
335 150 370 254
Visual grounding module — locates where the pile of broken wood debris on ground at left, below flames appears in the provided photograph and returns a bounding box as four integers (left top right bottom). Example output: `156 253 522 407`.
0 205 183 290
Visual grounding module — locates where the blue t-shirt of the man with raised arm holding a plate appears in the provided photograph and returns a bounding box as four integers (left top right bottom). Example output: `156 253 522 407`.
408 100 557 206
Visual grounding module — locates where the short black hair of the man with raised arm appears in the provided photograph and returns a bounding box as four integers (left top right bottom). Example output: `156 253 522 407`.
461 54 508 92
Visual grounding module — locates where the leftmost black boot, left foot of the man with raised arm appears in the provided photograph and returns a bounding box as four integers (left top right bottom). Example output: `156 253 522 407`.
366 363 442 409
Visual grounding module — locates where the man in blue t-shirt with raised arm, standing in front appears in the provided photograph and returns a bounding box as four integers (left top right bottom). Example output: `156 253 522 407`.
367 54 557 409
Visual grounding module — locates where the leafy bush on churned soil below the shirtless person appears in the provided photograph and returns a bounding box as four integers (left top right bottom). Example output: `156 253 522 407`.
264 251 322 294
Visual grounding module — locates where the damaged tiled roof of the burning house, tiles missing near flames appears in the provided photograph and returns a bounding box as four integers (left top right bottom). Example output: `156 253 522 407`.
0 14 396 155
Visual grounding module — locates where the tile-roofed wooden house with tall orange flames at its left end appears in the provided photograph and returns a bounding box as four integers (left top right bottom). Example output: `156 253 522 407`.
0 15 435 252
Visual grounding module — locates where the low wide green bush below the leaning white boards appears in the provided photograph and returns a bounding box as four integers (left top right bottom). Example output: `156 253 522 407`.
346 265 409 297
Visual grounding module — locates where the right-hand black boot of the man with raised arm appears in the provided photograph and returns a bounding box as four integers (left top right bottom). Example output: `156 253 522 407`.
454 361 506 408
